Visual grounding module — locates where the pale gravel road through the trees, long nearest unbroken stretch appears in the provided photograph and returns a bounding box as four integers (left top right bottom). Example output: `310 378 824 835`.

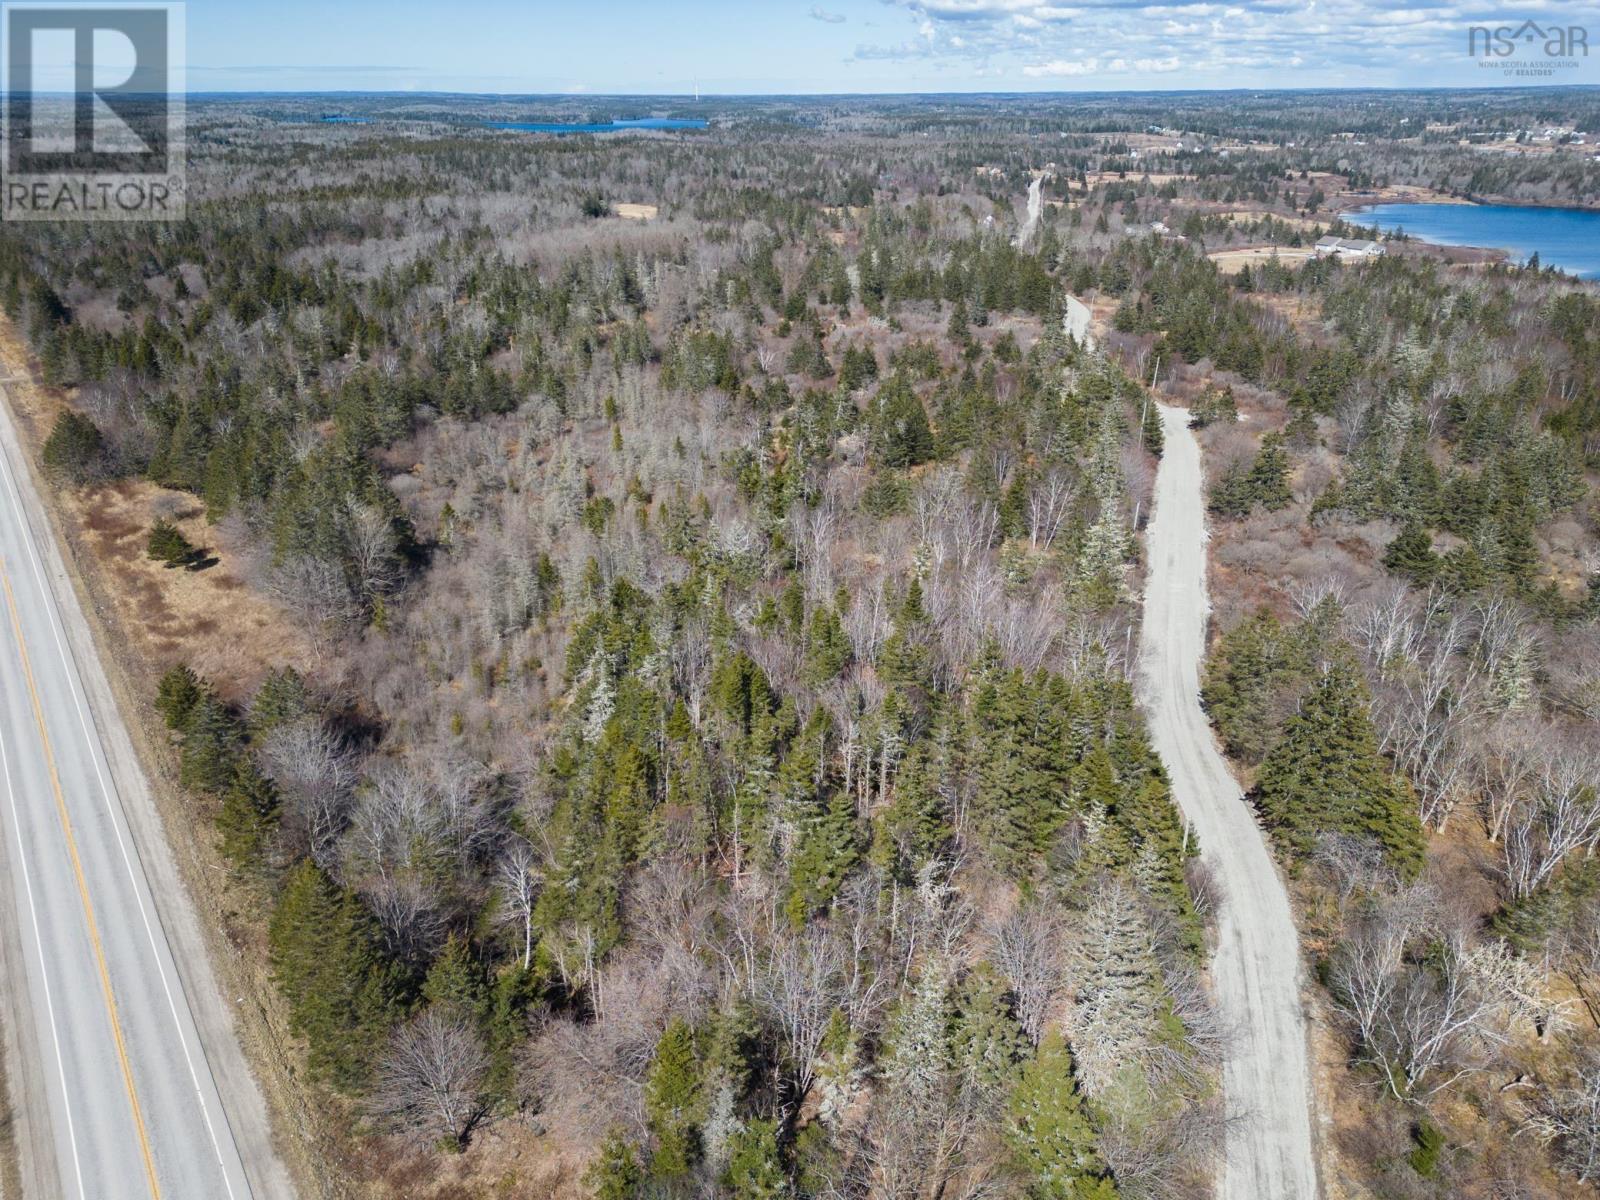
1139 405 1318 1200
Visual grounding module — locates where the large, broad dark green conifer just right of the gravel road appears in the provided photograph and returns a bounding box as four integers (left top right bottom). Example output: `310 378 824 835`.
1254 654 1424 877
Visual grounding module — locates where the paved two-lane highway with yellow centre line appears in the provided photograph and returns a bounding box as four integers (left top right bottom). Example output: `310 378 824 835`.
0 398 291 1200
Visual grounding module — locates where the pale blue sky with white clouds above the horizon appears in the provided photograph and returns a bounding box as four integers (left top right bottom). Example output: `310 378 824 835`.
187 0 1600 94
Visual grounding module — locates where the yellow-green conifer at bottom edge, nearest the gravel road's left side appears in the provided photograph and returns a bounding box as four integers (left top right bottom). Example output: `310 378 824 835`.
1005 1030 1117 1200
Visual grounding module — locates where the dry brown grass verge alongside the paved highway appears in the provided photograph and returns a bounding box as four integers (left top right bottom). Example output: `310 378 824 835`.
0 317 352 1200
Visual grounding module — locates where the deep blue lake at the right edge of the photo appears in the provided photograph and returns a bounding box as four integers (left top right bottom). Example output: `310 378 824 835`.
1347 205 1600 278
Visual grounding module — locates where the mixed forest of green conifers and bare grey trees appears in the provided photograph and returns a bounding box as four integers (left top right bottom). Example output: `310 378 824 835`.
0 93 1600 1200
